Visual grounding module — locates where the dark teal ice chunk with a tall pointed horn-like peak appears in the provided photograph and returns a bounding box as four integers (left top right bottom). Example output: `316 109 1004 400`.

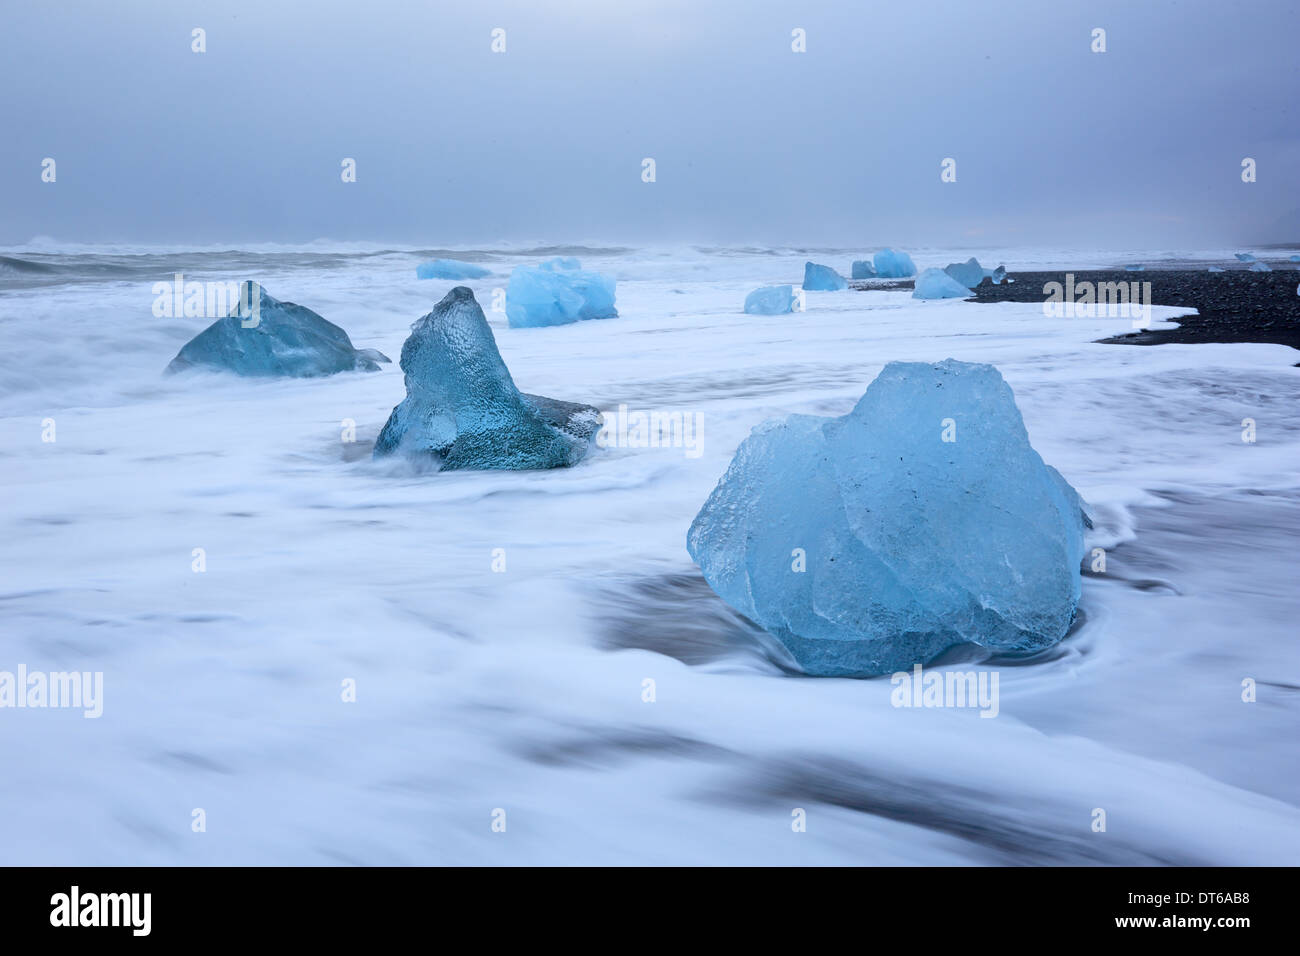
374 286 599 468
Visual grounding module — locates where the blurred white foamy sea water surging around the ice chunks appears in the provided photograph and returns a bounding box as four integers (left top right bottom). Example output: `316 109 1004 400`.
0 242 1300 865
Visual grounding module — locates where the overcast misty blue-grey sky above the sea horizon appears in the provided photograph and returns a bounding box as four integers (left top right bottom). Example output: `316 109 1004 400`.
0 0 1300 248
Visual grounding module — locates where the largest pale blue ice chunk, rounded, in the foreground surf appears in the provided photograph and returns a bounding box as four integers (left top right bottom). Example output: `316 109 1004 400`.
686 358 1083 675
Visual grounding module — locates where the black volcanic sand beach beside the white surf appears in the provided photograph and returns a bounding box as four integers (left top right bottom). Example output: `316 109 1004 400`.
974 263 1300 349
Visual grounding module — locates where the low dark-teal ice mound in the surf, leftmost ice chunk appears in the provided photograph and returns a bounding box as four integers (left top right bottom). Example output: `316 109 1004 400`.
166 282 390 378
